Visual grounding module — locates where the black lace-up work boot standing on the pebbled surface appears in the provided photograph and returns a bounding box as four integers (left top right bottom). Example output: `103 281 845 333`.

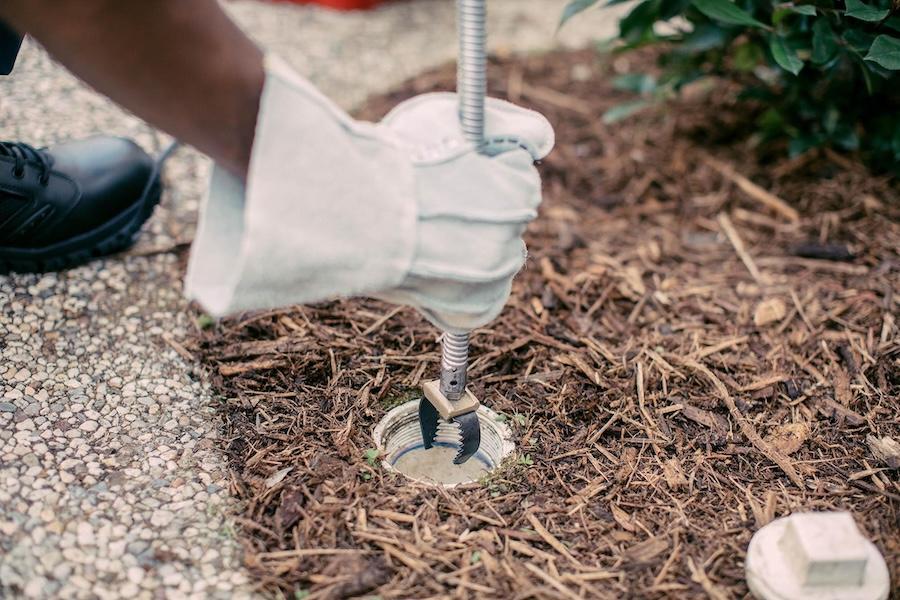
0 136 161 273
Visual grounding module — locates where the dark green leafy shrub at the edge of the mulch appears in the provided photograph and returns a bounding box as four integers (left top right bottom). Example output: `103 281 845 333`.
562 0 900 171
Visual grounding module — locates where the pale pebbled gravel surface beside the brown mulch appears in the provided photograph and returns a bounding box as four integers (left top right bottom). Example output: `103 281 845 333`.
0 0 614 598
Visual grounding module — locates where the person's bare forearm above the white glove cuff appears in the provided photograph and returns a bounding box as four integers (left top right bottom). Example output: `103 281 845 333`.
0 0 265 177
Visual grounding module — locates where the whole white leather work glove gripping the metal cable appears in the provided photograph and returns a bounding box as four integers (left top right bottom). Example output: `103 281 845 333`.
185 56 553 332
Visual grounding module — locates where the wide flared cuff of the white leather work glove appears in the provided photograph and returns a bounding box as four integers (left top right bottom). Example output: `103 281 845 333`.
185 56 416 316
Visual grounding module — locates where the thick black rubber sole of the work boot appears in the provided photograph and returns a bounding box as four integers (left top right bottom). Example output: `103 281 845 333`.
0 175 162 275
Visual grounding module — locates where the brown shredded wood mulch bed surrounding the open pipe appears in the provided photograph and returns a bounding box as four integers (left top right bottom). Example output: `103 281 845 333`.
190 51 900 598
